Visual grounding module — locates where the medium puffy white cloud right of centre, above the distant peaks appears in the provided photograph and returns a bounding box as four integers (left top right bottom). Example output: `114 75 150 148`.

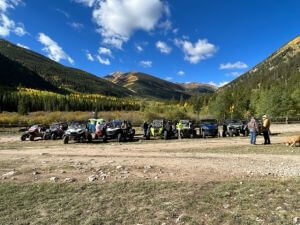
175 39 218 64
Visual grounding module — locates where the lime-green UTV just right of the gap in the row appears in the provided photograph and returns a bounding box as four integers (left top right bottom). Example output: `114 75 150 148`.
146 120 176 140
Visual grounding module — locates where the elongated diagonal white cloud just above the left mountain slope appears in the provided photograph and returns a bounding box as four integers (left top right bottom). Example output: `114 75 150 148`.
38 33 74 64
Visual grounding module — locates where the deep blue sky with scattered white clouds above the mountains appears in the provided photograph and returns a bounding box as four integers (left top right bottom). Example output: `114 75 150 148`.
0 0 300 85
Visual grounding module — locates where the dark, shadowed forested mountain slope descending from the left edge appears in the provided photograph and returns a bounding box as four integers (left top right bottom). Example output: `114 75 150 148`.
0 40 133 97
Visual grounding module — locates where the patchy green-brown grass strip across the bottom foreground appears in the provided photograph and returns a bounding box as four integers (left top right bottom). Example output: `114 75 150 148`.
0 178 300 225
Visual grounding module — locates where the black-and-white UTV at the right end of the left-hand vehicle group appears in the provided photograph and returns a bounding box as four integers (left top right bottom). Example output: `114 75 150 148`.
106 120 135 142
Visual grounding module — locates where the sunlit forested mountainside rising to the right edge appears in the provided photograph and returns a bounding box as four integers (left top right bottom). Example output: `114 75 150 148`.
210 36 300 117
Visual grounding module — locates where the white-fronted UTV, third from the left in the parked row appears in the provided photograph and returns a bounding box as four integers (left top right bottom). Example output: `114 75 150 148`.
63 122 93 144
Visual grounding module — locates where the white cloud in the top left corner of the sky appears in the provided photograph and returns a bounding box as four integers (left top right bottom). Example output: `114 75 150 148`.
0 0 27 37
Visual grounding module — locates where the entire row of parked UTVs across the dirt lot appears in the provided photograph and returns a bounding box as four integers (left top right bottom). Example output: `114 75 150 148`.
21 119 261 144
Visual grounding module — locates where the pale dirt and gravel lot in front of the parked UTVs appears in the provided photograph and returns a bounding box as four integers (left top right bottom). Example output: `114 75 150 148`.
0 125 300 183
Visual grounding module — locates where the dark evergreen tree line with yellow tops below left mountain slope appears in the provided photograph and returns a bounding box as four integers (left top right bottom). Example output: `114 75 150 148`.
0 88 140 114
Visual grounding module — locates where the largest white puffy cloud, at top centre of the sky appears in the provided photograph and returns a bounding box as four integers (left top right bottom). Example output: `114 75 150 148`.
81 0 170 49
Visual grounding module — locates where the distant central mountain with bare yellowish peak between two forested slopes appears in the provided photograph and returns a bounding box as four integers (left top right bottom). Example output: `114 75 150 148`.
104 72 214 99
